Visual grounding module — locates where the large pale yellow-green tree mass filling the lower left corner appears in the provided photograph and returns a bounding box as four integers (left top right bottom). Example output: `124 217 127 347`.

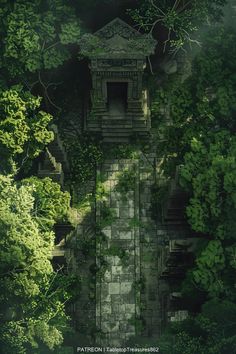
0 175 71 354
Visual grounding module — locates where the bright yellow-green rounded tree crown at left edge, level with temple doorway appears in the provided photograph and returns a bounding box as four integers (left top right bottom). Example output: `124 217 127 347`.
0 86 53 174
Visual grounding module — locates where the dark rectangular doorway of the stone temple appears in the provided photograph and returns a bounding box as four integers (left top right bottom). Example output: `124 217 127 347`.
107 82 128 119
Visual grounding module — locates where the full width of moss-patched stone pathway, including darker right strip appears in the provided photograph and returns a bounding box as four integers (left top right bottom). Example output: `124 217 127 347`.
96 155 160 347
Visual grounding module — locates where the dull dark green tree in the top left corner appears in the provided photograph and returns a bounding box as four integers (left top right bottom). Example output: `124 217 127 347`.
0 0 80 112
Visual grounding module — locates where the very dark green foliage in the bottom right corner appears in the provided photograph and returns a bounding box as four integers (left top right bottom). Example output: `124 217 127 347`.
158 300 236 354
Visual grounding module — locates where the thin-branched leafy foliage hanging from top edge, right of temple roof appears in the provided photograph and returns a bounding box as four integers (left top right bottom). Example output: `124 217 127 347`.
128 0 226 51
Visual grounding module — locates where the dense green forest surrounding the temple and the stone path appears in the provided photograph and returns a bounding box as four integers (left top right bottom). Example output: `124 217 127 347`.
0 0 236 354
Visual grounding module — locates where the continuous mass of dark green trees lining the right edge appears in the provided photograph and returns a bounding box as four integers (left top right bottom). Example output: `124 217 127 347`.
152 26 236 348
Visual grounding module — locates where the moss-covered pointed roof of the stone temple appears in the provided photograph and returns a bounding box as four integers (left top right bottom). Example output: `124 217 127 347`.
80 18 156 58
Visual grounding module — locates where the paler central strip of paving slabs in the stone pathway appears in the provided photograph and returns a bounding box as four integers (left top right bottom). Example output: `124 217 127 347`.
96 160 140 347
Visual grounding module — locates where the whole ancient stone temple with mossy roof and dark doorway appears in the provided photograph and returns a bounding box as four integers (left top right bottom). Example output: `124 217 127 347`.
80 18 156 142
